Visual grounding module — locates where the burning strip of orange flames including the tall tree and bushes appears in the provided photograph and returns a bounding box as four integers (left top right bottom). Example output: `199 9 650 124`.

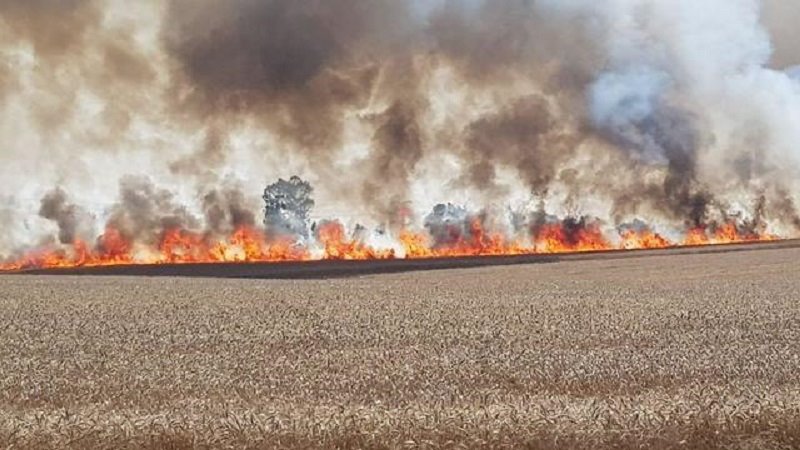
0 177 778 271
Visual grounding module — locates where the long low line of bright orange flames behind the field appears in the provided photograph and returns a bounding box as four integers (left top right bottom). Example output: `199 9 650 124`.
0 219 778 271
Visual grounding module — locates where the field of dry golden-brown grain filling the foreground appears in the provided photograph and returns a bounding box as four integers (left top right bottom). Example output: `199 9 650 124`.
0 249 800 449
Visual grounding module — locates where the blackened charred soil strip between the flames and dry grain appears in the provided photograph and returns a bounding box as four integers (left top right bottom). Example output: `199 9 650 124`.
7 239 800 280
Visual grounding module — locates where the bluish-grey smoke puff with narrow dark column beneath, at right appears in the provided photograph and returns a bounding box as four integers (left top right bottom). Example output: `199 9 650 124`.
591 68 713 227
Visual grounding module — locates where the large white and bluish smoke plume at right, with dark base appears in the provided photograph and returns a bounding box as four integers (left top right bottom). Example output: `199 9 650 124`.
544 1 800 225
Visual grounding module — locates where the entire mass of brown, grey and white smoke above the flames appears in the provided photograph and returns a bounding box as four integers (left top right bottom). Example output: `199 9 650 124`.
0 0 800 254
